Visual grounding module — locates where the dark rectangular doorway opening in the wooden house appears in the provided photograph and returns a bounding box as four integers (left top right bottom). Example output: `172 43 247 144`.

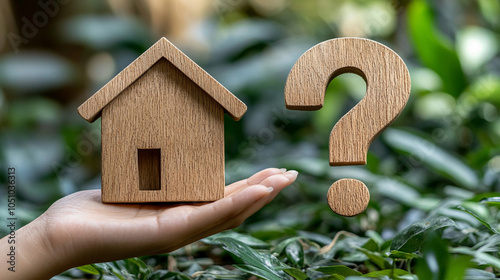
137 149 161 190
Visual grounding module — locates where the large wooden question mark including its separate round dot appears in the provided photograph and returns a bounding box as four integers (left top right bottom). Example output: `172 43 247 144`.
285 38 410 217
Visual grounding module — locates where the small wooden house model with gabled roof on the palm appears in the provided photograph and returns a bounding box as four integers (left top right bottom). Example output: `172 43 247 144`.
78 38 246 203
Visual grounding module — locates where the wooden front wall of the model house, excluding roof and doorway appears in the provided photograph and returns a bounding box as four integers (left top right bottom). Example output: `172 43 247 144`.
102 58 224 202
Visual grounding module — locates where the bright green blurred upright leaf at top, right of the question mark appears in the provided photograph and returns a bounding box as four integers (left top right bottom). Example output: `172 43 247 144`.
408 0 467 97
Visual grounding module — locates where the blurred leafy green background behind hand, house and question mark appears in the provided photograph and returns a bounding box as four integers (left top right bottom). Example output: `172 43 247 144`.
0 0 500 280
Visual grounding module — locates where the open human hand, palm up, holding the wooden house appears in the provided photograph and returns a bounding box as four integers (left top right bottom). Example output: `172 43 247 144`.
0 168 297 280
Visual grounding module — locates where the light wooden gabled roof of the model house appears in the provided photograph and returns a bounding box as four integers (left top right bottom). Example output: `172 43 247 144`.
78 37 247 122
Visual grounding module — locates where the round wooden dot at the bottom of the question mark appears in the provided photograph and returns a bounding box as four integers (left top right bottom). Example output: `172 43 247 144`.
327 179 370 217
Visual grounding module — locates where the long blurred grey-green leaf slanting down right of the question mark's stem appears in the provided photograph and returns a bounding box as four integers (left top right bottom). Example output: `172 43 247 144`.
383 128 479 189
